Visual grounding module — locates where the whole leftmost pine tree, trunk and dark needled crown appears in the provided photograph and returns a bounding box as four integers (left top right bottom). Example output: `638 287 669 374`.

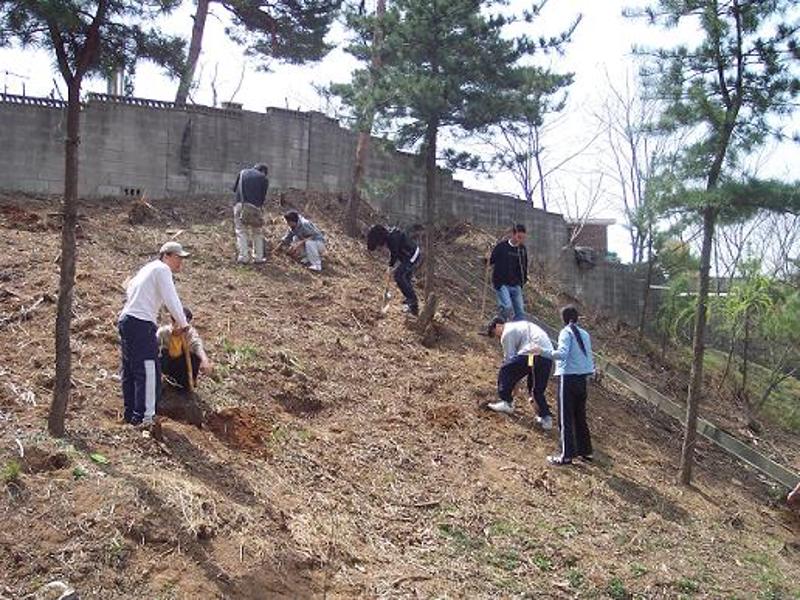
0 0 183 437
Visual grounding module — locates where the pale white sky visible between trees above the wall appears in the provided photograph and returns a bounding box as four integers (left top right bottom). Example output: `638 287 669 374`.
0 0 797 260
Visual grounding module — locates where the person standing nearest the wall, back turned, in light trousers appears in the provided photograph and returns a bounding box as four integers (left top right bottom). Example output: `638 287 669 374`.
233 163 269 264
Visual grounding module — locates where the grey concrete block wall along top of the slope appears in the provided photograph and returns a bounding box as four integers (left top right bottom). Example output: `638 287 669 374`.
0 94 643 322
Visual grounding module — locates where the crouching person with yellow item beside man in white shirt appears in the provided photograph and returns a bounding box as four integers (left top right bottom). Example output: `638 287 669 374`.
157 307 211 390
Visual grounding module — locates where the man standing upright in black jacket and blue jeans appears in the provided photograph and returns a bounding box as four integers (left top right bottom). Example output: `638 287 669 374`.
489 224 528 321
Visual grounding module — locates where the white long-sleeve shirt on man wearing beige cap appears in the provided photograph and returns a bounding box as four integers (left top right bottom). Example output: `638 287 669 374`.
119 260 187 327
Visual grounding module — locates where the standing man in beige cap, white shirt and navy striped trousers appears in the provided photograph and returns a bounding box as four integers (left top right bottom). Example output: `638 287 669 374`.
118 242 189 425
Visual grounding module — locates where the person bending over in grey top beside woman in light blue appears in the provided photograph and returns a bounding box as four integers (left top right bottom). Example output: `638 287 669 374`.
487 317 553 429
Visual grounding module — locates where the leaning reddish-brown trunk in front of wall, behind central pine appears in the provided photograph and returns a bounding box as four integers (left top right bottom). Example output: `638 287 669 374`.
344 0 386 236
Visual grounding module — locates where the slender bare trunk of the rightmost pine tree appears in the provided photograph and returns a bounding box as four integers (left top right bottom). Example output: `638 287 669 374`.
680 206 717 485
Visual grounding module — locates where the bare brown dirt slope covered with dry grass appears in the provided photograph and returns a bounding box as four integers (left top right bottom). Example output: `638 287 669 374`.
0 194 800 600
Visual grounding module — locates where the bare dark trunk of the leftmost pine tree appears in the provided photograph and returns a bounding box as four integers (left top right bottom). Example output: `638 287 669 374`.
47 76 81 437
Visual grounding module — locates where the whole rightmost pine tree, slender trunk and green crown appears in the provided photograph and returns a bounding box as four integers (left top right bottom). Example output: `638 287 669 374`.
636 0 800 484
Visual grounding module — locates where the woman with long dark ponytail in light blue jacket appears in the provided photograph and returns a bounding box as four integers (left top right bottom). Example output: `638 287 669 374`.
532 306 594 465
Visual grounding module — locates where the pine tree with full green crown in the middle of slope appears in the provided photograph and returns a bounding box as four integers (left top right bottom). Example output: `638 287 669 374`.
338 0 572 297
